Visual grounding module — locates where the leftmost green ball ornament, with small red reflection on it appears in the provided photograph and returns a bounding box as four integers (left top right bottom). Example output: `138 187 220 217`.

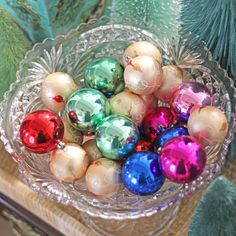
66 88 110 131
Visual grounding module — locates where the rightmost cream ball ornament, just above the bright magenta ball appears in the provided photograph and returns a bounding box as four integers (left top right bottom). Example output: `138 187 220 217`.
187 106 228 146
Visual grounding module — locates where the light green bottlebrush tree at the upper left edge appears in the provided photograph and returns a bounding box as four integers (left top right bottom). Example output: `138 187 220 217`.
0 7 31 100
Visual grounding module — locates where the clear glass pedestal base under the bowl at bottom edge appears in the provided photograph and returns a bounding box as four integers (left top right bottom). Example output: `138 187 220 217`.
81 201 180 236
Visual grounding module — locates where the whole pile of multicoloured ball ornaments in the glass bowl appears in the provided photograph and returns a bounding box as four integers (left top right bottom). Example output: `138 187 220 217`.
20 41 228 197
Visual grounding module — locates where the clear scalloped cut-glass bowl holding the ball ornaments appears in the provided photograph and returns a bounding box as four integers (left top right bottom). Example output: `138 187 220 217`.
0 18 236 230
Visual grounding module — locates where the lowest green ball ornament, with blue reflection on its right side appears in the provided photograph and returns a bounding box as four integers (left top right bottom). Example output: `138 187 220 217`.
95 115 139 160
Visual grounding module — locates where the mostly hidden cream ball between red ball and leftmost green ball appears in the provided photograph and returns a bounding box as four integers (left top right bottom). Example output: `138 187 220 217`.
62 117 83 144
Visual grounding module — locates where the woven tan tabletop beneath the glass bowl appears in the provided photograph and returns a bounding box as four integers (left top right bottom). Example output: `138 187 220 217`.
0 143 236 236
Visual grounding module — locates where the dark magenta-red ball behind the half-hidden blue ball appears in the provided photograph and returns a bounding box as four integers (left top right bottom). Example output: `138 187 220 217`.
141 107 175 142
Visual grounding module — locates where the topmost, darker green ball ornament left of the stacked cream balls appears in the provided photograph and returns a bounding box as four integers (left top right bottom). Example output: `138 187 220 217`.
84 57 125 97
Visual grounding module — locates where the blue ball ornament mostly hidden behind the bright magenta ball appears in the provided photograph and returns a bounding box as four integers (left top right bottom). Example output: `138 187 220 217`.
155 126 189 150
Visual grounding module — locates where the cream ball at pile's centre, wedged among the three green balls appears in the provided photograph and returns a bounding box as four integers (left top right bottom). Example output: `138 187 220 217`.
110 91 147 125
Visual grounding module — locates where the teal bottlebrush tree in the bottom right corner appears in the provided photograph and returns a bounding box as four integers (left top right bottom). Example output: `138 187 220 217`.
189 177 236 236
